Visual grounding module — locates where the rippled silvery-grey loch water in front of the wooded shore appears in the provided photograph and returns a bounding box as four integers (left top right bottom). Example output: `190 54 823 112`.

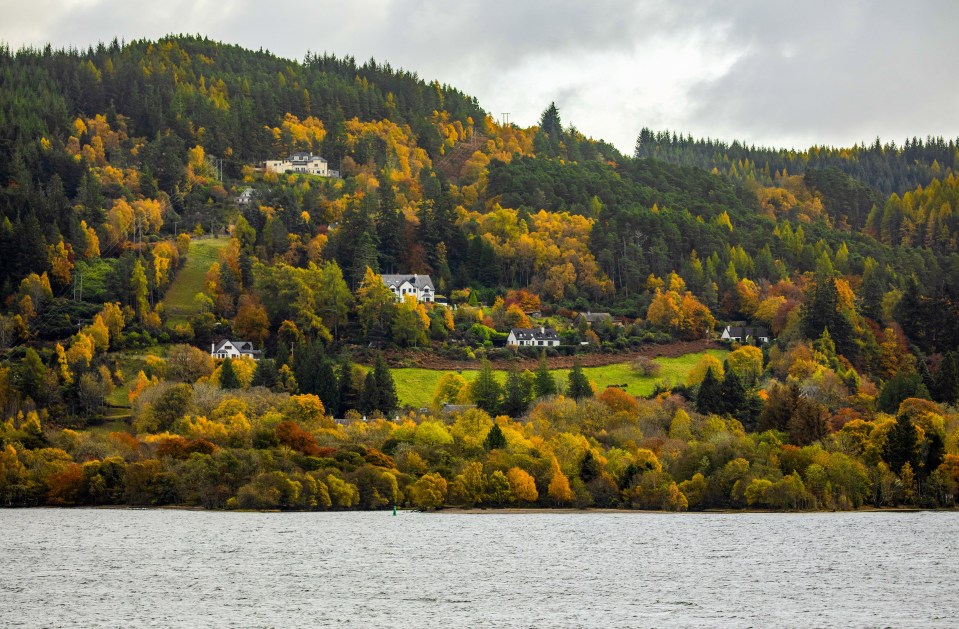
0 509 959 627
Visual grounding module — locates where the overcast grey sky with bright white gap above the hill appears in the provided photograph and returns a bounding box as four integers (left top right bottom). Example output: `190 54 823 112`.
0 0 959 153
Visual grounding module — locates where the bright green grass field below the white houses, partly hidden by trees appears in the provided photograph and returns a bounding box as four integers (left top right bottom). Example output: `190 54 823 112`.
392 349 728 408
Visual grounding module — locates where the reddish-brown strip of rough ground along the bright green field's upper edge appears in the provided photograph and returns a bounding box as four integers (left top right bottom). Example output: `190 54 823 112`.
388 340 722 370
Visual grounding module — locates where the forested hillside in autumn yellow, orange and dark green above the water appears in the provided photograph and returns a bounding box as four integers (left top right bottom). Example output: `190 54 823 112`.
0 36 959 509
